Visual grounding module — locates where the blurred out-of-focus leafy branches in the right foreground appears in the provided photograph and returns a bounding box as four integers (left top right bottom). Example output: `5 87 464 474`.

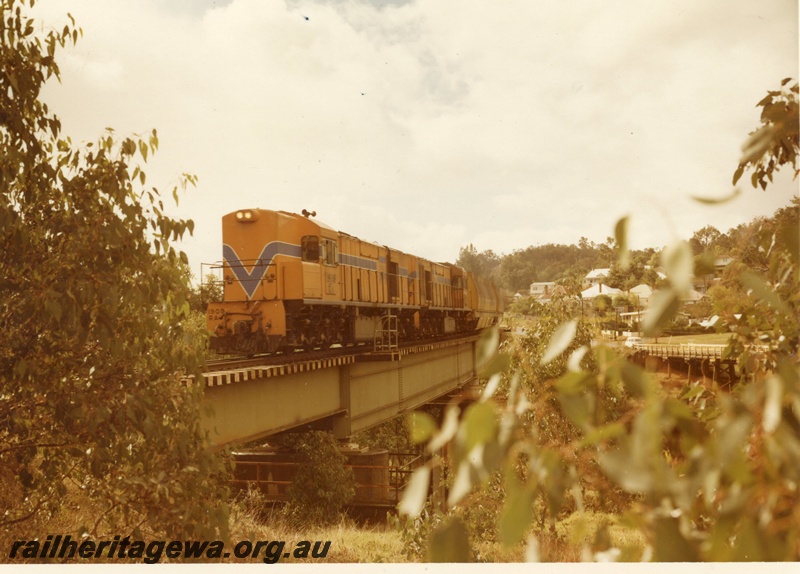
400 82 800 562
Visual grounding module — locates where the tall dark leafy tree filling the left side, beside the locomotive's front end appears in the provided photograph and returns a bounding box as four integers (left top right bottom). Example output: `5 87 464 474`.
0 0 227 539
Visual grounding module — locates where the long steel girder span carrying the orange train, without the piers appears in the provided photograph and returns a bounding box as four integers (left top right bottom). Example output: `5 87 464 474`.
184 336 478 446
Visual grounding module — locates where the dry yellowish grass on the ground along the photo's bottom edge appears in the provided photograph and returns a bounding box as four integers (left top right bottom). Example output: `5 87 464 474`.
0 466 644 564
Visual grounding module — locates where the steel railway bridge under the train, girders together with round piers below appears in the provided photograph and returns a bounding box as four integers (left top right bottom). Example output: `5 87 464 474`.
185 335 478 516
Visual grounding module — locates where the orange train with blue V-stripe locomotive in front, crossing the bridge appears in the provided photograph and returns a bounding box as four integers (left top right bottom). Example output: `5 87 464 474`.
207 209 502 354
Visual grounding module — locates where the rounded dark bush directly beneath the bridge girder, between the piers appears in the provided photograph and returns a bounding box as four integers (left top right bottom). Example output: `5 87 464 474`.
282 431 356 524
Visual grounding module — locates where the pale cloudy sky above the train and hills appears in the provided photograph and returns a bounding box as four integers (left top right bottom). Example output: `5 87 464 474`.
35 0 798 275
